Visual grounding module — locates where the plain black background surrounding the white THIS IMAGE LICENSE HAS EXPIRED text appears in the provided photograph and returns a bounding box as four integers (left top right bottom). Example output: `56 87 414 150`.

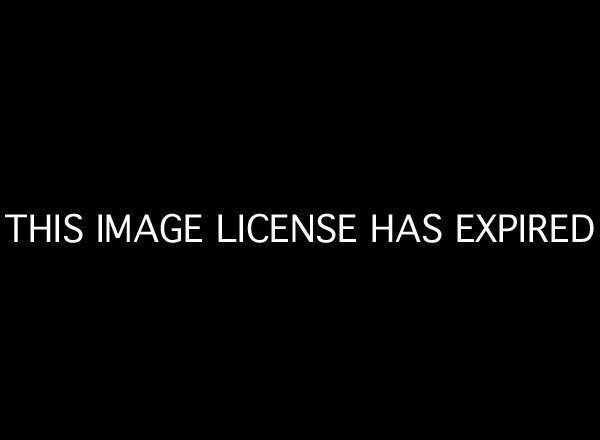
1 5 598 433
